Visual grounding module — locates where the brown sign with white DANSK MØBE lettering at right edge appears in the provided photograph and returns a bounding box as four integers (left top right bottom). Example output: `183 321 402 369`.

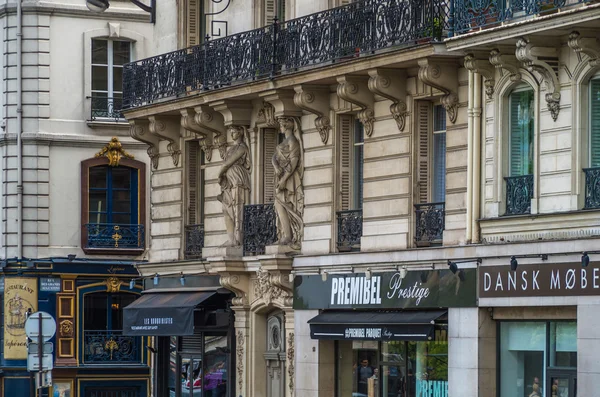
479 263 600 298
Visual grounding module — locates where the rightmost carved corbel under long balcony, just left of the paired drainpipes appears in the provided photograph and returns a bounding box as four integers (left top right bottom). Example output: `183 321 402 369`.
419 59 458 124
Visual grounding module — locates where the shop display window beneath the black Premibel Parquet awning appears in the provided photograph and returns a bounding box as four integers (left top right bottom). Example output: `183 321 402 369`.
336 325 448 397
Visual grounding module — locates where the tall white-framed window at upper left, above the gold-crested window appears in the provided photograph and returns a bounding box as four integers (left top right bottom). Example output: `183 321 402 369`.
92 39 131 118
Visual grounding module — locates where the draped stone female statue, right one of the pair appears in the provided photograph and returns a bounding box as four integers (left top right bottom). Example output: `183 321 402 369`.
273 117 304 249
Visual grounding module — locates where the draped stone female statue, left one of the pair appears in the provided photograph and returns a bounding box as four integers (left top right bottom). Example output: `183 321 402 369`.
217 125 252 246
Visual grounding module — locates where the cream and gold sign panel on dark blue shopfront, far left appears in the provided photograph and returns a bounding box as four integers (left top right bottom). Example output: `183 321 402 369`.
4 277 38 360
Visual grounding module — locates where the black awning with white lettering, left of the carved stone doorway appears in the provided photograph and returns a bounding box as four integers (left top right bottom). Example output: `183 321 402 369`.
123 291 216 336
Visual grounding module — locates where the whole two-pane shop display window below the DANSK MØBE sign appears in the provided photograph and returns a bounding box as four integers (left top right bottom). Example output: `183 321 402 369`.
499 321 577 397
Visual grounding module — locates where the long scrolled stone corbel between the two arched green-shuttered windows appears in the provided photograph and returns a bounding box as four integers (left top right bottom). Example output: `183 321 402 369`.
515 37 560 121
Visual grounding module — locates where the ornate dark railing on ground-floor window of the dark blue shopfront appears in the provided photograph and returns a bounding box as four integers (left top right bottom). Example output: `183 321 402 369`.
83 331 142 364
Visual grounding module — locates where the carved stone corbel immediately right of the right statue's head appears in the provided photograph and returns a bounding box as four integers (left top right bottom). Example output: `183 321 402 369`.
294 85 331 144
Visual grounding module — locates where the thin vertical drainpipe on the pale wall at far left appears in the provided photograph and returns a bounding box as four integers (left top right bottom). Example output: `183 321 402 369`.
17 0 23 259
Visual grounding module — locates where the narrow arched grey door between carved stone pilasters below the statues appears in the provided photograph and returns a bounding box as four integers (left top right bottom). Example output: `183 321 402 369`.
265 314 285 397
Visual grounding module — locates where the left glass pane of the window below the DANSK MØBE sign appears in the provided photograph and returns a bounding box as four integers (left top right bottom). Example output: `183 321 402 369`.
500 322 546 397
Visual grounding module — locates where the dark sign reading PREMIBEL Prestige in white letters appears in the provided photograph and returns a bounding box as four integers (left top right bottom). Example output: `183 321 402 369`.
294 269 477 310
